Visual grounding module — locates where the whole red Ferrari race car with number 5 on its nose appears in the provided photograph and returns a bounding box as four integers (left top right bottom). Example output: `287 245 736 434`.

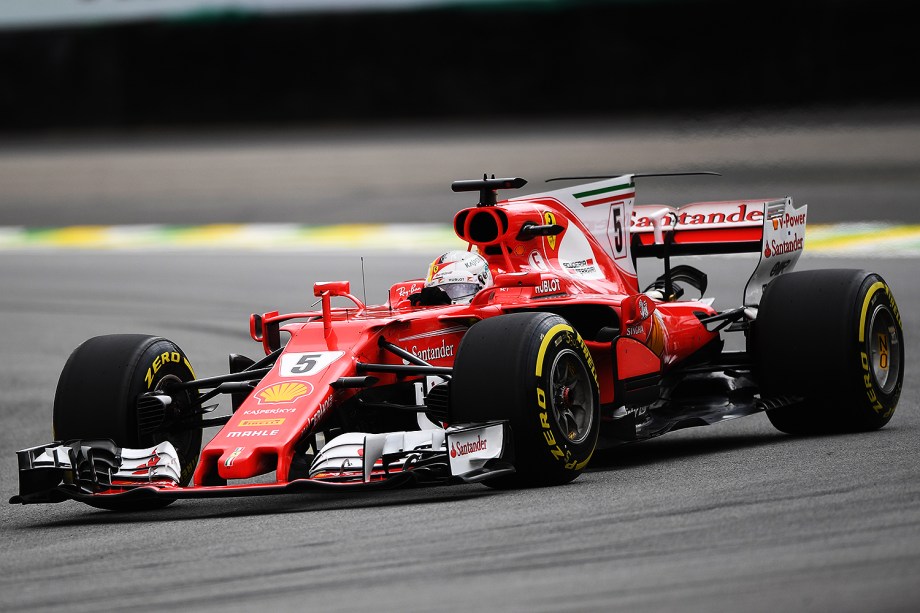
10 174 904 510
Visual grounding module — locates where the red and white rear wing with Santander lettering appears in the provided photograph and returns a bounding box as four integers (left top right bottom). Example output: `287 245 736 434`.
630 197 808 306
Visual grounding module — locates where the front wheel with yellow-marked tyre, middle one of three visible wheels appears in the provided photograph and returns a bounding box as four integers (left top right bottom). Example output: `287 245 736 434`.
450 313 600 488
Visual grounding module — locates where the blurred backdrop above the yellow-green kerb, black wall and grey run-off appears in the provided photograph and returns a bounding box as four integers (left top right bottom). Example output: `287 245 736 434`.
0 0 920 237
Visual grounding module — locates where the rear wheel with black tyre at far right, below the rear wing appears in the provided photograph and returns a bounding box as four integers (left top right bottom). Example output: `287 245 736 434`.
752 269 904 434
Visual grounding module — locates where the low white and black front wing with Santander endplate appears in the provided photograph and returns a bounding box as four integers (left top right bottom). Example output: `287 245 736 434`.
10 422 514 506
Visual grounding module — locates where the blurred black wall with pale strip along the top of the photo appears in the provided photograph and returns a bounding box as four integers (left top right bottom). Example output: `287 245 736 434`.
0 0 920 133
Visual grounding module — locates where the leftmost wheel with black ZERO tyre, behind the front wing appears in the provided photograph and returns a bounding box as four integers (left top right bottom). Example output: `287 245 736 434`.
52 334 202 510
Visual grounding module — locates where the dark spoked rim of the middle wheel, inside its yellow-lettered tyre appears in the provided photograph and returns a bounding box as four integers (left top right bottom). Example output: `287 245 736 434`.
550 349 594 445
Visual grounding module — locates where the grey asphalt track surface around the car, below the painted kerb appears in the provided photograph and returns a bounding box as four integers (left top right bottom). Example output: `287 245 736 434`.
0 111 920 611
